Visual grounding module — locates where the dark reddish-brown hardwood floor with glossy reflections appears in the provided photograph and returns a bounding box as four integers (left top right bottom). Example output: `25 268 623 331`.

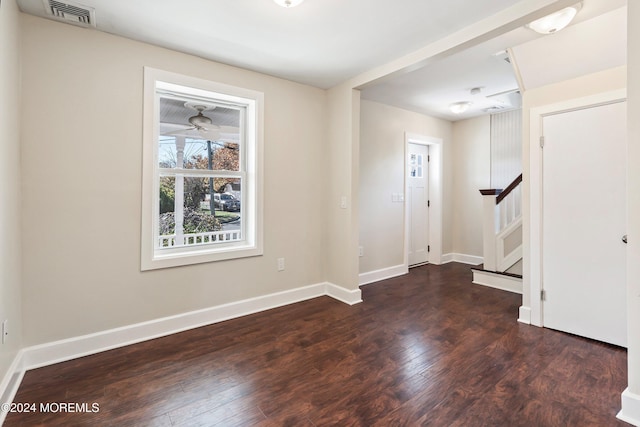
5 264 627 427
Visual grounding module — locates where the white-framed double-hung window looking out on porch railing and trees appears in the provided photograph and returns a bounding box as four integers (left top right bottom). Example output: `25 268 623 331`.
141 68 263 270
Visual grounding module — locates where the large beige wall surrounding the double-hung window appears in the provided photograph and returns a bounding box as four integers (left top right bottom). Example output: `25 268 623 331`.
18 15 331 345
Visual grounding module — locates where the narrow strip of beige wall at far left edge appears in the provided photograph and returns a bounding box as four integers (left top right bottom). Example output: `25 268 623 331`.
0 0 22 384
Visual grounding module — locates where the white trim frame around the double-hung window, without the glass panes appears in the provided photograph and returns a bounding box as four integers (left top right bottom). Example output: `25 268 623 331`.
140 67 264 271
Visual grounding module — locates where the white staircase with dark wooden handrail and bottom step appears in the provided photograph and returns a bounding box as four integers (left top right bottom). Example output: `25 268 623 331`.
472 175 522 294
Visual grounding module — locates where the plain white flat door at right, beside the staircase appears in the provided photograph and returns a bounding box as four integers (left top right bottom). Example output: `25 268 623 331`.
542 102 627 346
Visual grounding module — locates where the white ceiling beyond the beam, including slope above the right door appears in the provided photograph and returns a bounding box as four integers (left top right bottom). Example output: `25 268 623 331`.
362 0 627 121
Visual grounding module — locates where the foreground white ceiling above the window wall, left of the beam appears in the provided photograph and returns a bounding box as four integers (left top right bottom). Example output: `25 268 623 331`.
18 0 519 88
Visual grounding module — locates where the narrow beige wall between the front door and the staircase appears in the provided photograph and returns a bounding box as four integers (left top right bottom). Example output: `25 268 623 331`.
453 115 491 257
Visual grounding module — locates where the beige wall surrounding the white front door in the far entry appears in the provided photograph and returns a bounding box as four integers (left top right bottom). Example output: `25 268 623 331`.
358 100 453 273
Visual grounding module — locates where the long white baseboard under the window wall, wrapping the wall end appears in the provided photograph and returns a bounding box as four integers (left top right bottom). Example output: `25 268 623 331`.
16 282 362 370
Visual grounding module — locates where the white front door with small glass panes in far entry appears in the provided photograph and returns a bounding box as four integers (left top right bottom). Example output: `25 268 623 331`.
407 144 429 266
